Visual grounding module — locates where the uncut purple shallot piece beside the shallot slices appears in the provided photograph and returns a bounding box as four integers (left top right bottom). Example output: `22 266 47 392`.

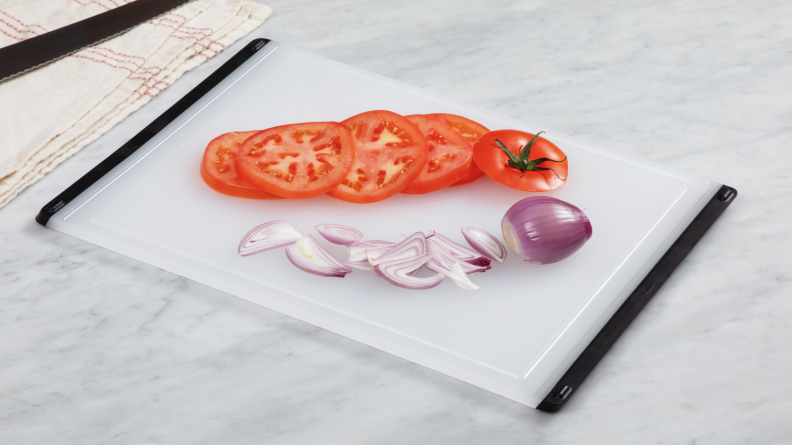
501 196 593 264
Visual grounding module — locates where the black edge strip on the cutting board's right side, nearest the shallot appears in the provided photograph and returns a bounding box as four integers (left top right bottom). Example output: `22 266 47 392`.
537 185 737 412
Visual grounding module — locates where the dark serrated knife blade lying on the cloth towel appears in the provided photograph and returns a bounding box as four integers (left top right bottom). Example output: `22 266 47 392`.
0 0 188 80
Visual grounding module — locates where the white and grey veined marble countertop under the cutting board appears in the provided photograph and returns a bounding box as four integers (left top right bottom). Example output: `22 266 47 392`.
0 0 792 445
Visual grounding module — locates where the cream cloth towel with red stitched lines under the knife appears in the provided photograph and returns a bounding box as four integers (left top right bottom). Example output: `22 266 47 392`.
0 0 272 208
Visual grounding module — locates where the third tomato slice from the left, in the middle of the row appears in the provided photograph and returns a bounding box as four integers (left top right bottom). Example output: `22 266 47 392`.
328 110 428 204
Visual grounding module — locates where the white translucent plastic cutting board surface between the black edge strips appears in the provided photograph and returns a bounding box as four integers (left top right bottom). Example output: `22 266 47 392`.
47 42 720 407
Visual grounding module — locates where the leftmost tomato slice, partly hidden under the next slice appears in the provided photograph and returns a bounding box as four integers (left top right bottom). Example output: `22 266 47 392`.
201 131 281 199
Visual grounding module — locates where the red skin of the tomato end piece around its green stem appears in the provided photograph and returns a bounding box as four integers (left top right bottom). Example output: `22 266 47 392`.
473 130 569 192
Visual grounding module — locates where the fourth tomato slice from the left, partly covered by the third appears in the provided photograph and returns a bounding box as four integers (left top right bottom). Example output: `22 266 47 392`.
402 114 473 195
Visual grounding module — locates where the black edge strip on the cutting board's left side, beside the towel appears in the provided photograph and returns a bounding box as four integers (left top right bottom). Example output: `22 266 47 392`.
36 39 269 226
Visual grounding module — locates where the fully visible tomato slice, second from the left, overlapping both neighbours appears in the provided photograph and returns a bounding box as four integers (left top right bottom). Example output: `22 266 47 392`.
236 122 355 199
